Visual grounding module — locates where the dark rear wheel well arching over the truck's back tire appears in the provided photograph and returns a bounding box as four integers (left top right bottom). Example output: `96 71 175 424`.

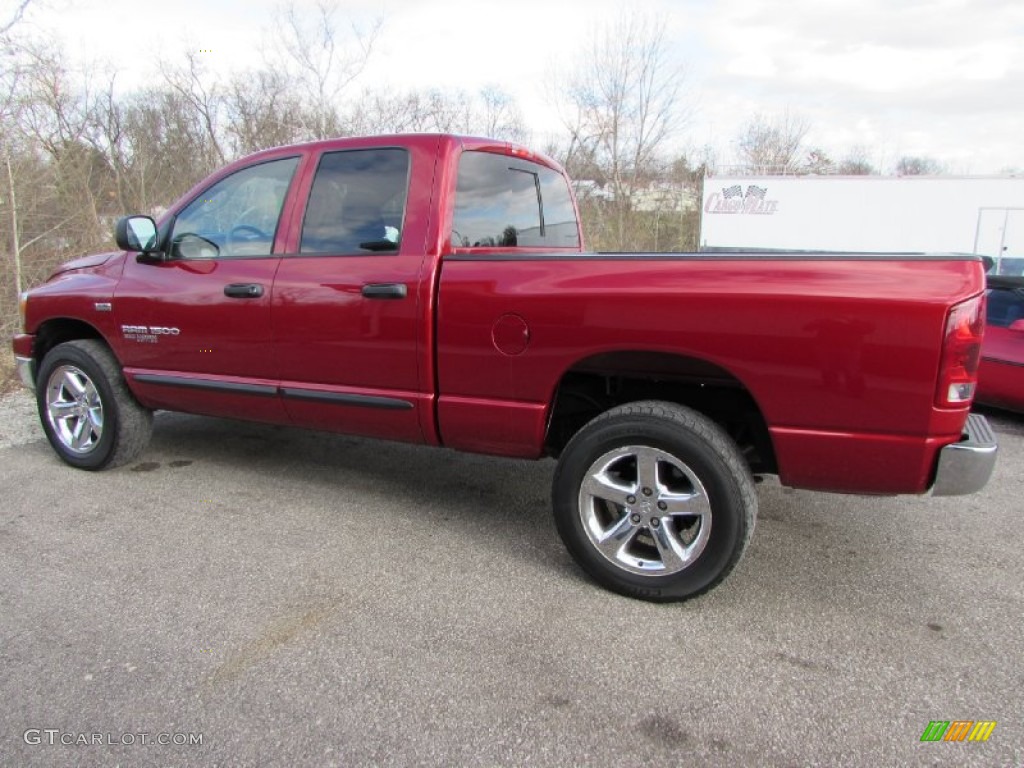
545 352 777 473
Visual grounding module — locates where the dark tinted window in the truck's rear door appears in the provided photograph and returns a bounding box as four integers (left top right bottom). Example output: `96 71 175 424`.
299 148 409 255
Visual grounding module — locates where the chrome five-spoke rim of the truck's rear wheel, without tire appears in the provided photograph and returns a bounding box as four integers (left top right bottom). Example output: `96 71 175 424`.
580 445 712 575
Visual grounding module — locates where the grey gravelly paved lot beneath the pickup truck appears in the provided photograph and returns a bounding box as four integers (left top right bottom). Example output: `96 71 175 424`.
0 394 1024 766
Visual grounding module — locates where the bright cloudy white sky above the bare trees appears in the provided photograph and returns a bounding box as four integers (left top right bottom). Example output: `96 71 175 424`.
8 0 1024 174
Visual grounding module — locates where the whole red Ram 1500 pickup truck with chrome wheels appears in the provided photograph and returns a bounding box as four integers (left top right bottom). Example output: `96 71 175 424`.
13 135 996 600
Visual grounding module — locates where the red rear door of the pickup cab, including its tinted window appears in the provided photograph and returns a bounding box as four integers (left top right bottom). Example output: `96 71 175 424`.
271 141 436 442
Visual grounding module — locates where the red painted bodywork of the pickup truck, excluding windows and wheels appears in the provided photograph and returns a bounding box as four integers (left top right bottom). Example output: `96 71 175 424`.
15 135 995 493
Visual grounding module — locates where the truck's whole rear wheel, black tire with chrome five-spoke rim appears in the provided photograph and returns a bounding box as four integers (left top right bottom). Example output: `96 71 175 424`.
552 400 758 602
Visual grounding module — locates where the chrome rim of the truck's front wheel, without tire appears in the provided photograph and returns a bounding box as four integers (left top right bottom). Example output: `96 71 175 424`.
46 365 103 454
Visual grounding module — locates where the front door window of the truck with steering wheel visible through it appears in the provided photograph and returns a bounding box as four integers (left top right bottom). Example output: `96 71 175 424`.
171 158 299 259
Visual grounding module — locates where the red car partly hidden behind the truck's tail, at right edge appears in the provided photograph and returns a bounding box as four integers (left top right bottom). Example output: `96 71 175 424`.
975 274 1024 413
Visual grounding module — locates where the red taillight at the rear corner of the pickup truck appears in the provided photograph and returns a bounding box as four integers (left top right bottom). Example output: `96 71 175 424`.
935 295 985 408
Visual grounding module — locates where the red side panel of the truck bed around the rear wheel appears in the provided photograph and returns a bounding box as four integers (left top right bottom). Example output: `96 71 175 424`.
438 258 981 493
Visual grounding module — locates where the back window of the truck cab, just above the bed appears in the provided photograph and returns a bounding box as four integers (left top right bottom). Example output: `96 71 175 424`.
452 152 580 248
